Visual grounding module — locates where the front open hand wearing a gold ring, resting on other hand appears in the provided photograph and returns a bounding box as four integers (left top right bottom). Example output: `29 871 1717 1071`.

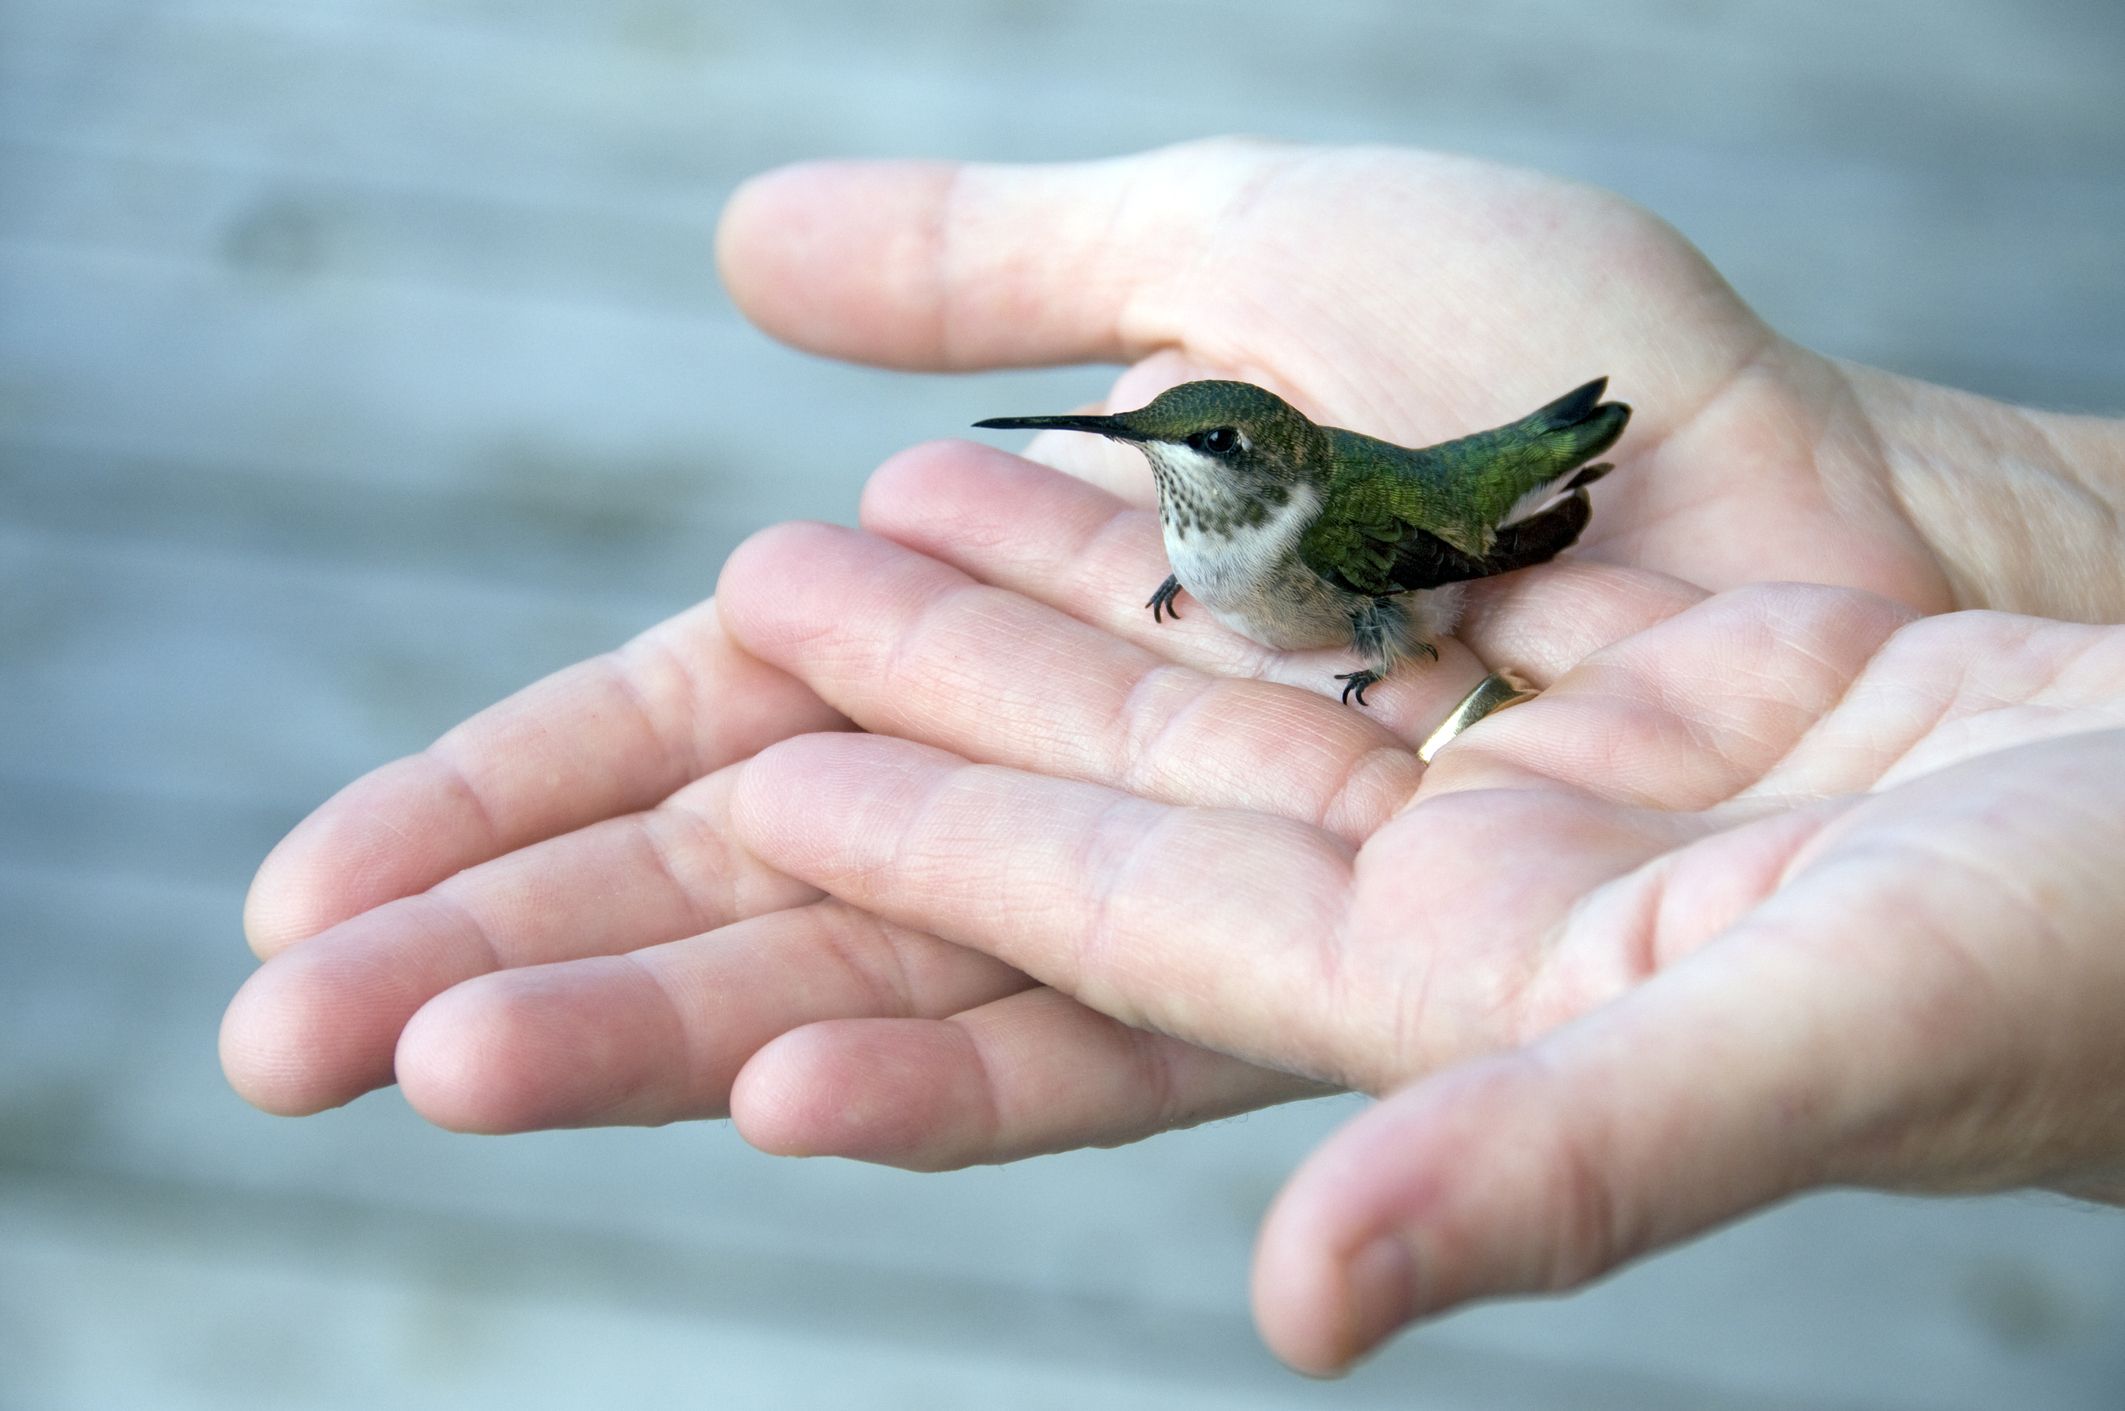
723 448 2125 1373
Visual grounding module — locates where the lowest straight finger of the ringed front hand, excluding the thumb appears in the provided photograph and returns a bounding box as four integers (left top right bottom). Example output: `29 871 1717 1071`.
731 735 1373 1084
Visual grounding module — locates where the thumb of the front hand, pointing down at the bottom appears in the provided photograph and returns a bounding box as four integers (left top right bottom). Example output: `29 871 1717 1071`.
1254 935 1866 1375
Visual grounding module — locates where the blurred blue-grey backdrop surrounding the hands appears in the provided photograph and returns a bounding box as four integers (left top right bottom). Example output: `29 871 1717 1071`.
0 0 2125 1411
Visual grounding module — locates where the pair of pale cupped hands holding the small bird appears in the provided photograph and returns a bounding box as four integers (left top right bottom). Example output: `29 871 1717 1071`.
223 142 2125 1373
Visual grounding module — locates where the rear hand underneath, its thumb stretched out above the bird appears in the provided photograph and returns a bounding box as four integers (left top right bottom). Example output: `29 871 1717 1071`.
223 142 2114 1215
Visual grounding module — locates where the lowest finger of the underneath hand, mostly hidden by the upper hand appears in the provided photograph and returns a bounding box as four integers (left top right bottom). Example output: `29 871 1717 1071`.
731 988 1326 1171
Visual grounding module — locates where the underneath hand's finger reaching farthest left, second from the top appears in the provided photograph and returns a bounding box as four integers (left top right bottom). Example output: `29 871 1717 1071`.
221 769 818 1114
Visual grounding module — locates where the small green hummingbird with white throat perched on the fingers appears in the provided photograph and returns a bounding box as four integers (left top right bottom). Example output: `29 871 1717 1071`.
973 378 1630 706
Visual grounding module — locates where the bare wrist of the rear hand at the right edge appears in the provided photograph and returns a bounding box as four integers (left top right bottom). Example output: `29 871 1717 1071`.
1845 366 2125 623
